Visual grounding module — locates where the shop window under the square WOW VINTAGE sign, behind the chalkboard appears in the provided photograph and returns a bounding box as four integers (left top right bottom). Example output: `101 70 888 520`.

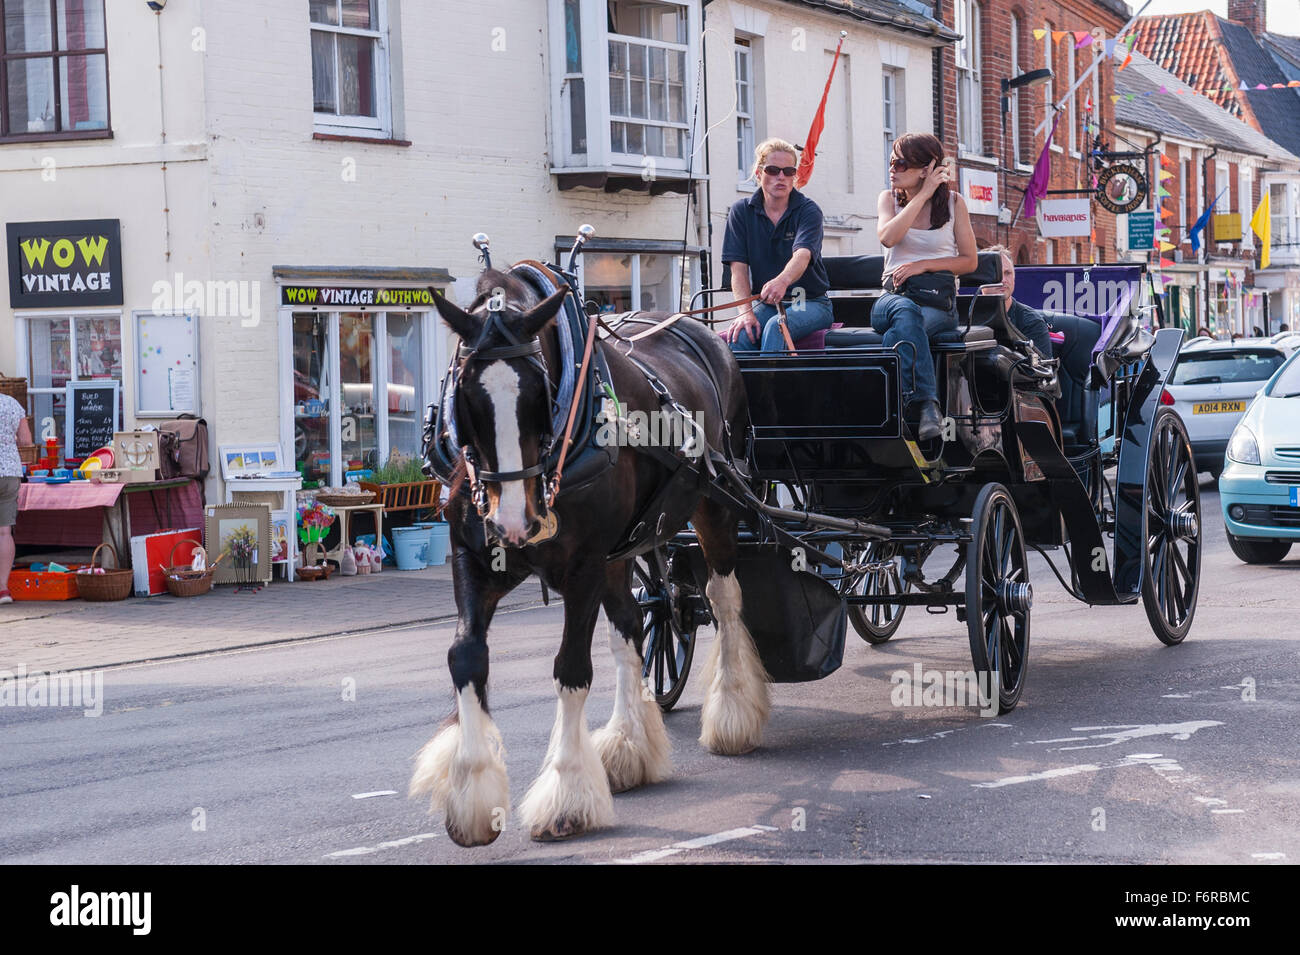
22 314 126 446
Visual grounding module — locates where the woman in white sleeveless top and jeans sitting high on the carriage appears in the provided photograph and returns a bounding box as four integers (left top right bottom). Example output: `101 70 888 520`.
871 133 979 440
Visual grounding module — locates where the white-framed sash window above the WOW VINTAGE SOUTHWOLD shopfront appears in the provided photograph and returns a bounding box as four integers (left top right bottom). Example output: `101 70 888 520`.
311 0 393 136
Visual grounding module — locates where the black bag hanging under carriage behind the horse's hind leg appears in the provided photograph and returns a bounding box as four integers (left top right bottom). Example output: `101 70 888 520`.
736 546 848 683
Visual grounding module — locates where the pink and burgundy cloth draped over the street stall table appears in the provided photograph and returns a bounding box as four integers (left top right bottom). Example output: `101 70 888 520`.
13 481 203 547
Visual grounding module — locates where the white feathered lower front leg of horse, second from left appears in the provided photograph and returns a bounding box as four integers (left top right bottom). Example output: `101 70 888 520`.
519 681 614 835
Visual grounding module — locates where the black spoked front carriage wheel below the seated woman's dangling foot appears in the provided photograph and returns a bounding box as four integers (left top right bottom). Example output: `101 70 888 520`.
966 485 1034 713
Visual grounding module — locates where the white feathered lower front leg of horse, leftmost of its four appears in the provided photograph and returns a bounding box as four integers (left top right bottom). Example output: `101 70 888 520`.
410 685 510 846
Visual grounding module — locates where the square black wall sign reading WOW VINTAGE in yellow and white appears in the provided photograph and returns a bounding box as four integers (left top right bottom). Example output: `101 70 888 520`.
5 218 122 309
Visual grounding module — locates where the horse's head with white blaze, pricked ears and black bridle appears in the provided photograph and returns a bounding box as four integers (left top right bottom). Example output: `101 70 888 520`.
436 269 568 547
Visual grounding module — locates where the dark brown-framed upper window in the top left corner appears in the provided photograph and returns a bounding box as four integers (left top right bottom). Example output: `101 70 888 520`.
0 0 108 139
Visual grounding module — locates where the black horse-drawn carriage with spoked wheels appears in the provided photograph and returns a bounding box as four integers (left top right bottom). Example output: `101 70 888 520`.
634 253 1201 712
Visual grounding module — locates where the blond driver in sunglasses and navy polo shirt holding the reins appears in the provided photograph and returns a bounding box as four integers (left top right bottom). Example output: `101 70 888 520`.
723 139 831 352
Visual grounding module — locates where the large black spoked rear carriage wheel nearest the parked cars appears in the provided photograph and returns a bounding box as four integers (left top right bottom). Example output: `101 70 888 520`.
1141 408 1201 647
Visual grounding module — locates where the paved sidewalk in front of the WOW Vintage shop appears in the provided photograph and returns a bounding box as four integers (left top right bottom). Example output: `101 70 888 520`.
0 565 555 673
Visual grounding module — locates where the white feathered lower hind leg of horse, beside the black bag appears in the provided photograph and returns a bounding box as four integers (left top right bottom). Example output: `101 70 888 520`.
699 572 771 756
